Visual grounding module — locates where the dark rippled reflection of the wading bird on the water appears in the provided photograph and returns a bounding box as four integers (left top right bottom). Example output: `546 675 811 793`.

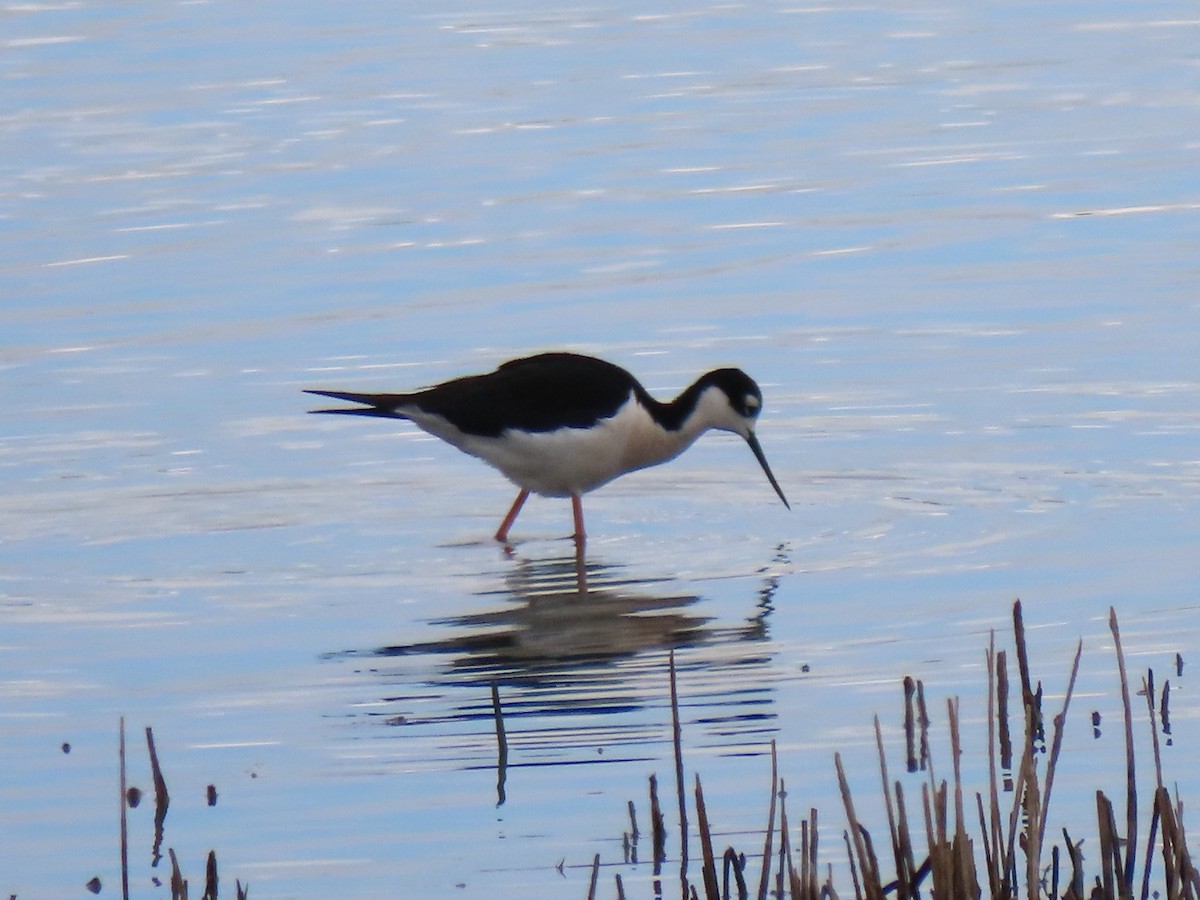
331 547 787 803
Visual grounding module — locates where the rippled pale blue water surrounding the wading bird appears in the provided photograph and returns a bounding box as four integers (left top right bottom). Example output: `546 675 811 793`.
0 2 1200 898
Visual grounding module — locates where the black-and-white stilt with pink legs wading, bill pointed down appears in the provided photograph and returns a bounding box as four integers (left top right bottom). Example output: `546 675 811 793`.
305 353 788 545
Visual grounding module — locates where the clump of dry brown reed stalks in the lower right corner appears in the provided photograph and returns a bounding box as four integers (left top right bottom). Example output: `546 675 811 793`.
604 601 1200 900
